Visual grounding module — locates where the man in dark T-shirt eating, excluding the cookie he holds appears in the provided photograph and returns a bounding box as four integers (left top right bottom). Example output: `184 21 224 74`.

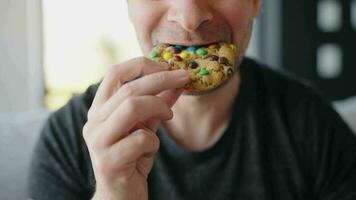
29 0 356 200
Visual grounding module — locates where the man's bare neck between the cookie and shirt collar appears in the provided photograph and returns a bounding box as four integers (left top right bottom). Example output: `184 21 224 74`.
164 74 240 150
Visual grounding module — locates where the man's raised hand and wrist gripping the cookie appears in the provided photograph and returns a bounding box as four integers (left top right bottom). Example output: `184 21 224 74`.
83 58 189 200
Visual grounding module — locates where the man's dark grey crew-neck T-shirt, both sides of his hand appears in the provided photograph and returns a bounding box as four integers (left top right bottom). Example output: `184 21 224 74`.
28 58 356 200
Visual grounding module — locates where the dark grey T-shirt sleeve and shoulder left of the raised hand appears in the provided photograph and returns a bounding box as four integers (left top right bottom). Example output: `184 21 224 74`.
27 85 97 199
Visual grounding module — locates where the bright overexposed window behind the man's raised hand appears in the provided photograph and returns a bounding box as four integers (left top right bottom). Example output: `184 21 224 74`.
43 0 141 110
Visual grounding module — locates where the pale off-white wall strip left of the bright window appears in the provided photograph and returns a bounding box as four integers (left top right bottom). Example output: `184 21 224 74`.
0 0 43 112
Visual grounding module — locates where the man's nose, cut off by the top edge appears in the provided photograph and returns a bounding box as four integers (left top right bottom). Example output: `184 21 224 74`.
167 0 213 32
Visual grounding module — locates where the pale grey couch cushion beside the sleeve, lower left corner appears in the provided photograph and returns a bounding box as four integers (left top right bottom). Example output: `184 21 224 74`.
0 110 49 200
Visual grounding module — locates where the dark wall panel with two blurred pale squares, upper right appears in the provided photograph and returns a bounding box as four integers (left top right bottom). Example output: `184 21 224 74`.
281 0 356 100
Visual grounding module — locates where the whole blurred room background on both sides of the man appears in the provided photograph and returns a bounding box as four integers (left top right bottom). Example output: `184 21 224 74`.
0 0 356 199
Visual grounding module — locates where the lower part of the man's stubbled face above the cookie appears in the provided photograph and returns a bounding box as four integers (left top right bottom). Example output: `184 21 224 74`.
128 0 260 61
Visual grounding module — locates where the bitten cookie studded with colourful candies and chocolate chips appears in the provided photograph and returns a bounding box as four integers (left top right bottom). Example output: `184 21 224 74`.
149 42 236 92
